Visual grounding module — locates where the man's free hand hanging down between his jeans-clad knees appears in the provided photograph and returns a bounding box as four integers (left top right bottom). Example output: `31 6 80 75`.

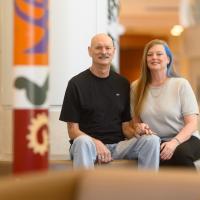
93 139 112 164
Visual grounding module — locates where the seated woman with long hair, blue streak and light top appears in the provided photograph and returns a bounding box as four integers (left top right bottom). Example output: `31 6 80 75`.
131 39 200 167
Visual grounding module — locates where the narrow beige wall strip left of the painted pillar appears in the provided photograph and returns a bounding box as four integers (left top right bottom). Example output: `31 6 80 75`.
0 0 13 160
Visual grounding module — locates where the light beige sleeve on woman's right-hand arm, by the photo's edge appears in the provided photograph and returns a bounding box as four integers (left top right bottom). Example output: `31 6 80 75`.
180 80 199 115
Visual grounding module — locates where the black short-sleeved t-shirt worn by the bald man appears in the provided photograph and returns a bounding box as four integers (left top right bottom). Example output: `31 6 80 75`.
60 69 131 144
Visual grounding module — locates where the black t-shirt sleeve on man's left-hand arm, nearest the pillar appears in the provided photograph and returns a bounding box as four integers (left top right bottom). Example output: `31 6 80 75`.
59 80 80 123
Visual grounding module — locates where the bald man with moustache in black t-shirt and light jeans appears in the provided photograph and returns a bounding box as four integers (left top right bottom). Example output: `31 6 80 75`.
60 33 160 170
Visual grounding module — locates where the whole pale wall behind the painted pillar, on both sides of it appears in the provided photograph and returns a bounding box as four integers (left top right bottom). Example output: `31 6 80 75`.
0 0 110 160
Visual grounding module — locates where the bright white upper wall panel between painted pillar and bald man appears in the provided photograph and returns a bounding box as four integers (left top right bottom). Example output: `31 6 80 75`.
50 0 107 105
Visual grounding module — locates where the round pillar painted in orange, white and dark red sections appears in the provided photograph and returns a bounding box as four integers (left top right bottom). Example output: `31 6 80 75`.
13 0 49 173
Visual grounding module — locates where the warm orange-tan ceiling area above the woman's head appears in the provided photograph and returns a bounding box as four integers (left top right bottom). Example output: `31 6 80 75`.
119 0 181 35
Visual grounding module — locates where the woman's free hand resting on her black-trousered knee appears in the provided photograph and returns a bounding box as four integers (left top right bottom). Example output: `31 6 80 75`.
160 139 179 160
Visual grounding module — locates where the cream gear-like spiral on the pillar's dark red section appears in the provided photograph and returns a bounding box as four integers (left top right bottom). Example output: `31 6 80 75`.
26 113 48 156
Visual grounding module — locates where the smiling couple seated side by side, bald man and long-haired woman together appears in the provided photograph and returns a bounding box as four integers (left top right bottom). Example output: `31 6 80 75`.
60 33 200 171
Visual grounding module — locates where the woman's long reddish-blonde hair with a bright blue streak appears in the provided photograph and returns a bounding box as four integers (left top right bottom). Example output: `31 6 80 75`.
131 39 178 117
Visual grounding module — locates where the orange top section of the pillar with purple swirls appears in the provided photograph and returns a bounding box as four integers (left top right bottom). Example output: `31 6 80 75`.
14 0 48 67
